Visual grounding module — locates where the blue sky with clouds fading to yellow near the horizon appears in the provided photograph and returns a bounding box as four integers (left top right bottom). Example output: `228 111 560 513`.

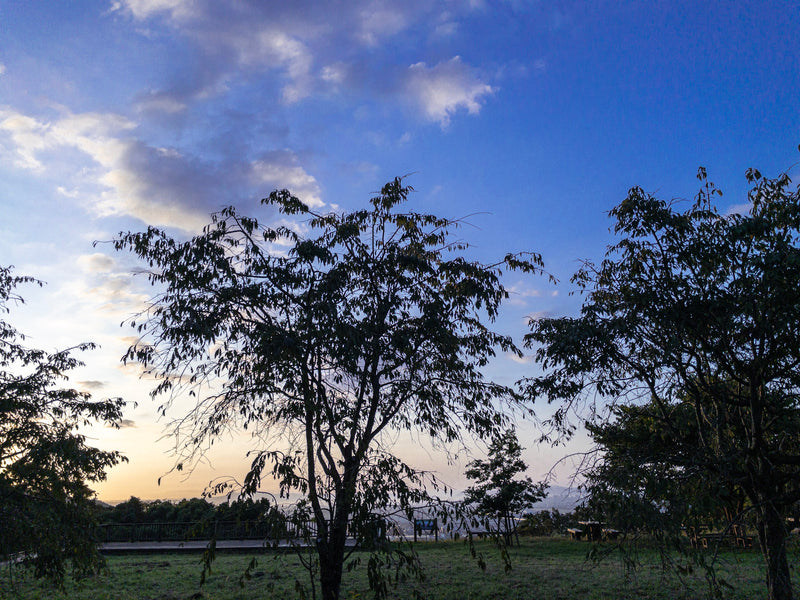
0 0 800 501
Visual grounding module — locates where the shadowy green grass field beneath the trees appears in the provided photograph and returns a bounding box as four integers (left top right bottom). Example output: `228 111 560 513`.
0 538 788 600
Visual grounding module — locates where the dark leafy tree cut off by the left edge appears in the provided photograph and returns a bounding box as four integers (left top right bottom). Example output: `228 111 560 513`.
0 268 125 584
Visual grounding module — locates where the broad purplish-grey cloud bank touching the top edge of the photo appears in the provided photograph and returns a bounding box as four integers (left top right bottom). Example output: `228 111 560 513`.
113 0 495 127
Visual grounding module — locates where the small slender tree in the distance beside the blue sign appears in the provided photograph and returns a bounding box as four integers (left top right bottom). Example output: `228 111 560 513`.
464 429 547 544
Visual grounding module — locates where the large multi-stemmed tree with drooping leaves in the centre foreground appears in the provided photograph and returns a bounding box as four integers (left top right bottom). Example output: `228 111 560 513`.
116 179 541 598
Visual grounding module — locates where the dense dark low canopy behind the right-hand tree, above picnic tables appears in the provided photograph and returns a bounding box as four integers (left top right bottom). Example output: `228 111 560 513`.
584 402 750 540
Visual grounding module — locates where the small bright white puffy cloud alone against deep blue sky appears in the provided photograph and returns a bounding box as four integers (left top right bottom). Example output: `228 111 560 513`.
406 56 495 128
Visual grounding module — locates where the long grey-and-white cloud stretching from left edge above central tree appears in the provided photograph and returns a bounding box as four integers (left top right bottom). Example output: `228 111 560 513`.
0 108 323 232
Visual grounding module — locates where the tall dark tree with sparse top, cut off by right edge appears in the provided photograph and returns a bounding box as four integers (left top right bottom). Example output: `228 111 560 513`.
527 164 800 599
